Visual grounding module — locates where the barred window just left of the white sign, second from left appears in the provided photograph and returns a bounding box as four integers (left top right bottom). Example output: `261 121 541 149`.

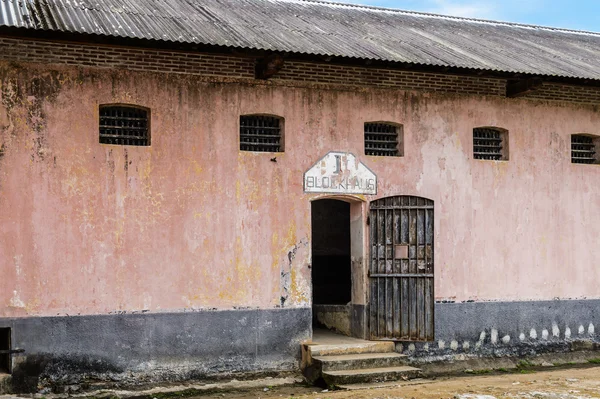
240 115 283 152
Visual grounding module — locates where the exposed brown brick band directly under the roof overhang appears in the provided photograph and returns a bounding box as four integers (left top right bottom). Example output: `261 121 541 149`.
0 37 600 104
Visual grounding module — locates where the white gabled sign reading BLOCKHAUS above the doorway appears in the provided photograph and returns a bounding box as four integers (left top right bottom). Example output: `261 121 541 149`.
304 151 377 195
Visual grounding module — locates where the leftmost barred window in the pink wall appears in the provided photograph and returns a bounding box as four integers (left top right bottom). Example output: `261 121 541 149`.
100 105 150 146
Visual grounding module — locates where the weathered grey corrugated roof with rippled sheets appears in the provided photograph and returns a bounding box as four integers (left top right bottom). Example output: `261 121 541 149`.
0 0 600 79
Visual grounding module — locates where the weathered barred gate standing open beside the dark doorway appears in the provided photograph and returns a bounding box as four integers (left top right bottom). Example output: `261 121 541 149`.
369 196 435 341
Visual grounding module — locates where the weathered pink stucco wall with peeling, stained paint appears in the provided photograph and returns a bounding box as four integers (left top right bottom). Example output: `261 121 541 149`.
0 64 600 316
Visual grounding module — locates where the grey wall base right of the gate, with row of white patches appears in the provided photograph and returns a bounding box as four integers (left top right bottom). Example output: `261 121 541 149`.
398 299 600 361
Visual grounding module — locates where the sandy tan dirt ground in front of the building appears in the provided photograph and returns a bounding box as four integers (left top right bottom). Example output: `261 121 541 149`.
197 367 600 399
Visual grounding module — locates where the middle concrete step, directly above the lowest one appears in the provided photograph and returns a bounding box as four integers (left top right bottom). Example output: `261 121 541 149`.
313 352 406 371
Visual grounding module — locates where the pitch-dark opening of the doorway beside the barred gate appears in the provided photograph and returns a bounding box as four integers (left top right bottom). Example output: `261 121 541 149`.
311 199 352 305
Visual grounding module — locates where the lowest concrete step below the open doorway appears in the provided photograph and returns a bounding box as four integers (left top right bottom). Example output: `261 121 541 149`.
322 366 421 386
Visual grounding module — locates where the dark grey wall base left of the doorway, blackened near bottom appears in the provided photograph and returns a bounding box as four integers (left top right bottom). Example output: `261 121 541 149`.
0 308 311 392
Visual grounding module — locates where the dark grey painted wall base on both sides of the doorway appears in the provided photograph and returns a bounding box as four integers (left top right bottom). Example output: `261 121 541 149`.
0 300 600 392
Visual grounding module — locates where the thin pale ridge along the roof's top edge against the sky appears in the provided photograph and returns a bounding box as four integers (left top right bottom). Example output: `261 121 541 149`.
284 0 600 36
